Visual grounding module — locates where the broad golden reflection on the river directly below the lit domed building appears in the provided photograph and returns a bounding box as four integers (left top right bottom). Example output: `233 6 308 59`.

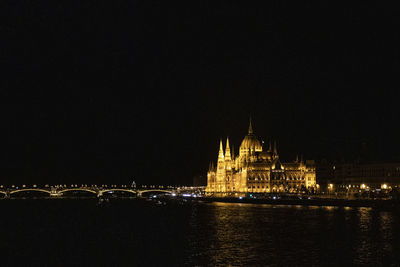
206 203 333 266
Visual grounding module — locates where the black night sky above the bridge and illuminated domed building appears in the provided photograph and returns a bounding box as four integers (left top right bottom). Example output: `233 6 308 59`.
0 0 400 184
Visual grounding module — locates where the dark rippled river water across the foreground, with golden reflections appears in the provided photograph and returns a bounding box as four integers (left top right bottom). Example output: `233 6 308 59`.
0 200 400 266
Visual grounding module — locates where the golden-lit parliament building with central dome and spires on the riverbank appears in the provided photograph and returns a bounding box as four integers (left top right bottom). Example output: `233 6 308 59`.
206 121 317 196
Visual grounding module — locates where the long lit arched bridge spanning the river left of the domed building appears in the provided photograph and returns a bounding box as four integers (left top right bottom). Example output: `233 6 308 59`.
0 185 183 198
